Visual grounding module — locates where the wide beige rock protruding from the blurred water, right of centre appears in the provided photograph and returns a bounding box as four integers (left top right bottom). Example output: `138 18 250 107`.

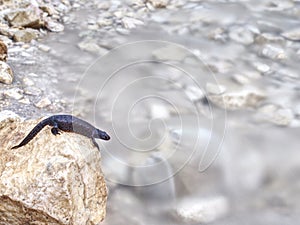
208 89 265 110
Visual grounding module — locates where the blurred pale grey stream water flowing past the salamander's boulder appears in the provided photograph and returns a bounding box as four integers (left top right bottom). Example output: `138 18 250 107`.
45 1 300 225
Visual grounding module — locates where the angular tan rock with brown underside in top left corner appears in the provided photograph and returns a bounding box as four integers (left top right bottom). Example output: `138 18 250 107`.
5 8 43 28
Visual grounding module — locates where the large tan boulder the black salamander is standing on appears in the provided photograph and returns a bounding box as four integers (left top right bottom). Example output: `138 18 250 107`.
0 113 107 225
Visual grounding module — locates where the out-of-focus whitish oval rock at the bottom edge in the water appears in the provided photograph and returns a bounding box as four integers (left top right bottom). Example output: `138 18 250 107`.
176 196 229 224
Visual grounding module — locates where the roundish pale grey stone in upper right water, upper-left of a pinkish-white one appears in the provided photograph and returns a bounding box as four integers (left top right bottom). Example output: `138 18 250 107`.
229 26 254 45
